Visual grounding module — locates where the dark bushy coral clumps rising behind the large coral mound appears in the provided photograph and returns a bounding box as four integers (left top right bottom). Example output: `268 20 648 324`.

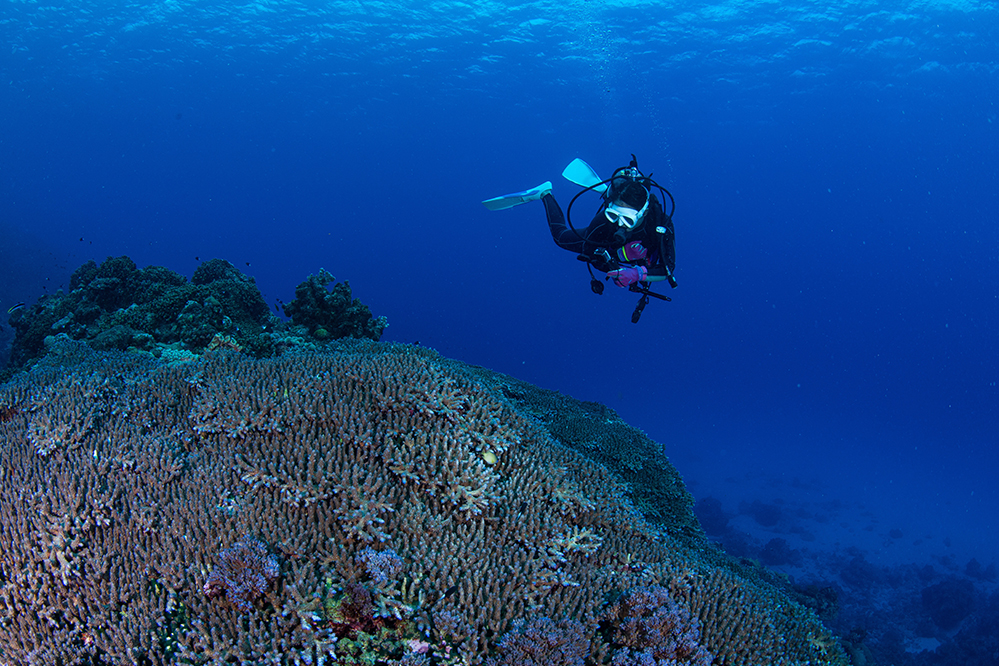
7 257 387 374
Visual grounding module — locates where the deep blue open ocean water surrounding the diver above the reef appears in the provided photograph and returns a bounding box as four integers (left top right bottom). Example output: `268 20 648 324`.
0 0 999 640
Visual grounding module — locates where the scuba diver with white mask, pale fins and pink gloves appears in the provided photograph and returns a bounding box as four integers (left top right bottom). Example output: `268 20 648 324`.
482 154 676 323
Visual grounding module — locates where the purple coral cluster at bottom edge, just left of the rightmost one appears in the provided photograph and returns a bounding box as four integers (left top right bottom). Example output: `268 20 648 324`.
486 617 590 666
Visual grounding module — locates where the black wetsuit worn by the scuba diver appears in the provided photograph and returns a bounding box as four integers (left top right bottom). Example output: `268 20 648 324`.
541 194 676 280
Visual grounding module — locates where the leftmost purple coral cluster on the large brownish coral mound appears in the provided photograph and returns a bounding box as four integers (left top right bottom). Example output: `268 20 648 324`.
203 535 280 613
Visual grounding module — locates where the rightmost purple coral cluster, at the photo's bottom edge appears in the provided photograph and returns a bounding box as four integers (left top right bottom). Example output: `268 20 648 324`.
603 585 712 666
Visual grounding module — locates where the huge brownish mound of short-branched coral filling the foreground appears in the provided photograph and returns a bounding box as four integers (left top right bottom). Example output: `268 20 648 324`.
0 340 846 666
